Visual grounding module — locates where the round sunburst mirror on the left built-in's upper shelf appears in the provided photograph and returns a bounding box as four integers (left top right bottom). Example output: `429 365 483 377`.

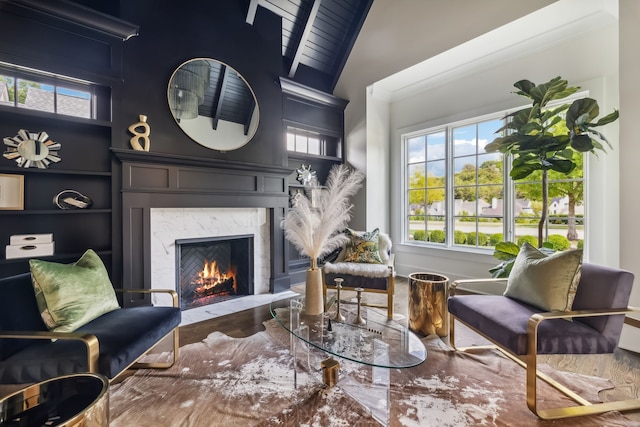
3 129 61 169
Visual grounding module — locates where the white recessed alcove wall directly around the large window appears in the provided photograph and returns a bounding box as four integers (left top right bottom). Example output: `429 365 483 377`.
384 25 620 278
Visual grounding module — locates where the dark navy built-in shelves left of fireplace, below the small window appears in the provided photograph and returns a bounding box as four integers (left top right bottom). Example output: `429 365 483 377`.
0 107 113 277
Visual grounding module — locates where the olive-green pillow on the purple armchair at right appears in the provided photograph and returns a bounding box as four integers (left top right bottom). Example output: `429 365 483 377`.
504 243 582 311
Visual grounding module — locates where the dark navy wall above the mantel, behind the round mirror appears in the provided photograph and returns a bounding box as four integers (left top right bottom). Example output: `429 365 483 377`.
113 0 287 166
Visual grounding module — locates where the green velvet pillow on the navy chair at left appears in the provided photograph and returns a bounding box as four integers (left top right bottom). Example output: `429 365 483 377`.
29 249 120 332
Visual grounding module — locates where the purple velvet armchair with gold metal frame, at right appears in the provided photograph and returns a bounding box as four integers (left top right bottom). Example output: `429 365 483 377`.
448 263 640 419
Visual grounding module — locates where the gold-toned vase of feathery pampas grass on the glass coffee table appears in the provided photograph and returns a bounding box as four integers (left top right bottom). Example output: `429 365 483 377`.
281 164 364 314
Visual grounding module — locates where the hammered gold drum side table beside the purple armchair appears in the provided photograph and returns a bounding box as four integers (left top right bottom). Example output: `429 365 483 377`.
409 273 449 337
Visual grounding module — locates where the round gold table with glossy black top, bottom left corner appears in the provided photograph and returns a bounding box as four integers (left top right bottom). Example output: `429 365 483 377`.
0 373 109 427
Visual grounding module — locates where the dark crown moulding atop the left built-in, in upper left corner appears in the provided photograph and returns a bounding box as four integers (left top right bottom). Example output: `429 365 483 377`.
2 0 139 41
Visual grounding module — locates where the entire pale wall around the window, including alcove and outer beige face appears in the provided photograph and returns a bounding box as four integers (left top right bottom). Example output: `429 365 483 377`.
335 0 640 351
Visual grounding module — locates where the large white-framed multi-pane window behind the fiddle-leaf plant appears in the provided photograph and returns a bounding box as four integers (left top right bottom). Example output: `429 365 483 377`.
402 113 585 250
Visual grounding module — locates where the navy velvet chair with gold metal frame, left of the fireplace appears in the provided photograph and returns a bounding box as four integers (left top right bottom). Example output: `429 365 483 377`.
0 273 181 384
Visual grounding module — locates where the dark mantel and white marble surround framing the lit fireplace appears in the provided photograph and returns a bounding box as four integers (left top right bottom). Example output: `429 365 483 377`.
112 149 292 321
